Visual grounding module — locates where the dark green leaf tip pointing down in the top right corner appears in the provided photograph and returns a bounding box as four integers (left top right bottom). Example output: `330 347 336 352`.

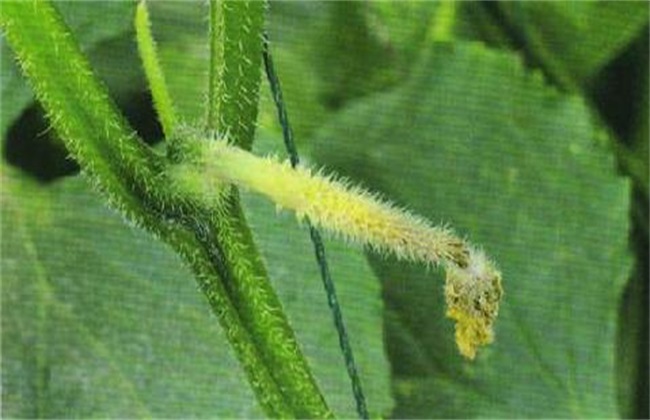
499 1 648 88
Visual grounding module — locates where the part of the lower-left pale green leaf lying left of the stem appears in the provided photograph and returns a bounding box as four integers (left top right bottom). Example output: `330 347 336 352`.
2 167 262 417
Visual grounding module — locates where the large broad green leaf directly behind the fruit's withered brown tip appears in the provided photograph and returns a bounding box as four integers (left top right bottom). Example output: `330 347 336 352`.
312 43 630 418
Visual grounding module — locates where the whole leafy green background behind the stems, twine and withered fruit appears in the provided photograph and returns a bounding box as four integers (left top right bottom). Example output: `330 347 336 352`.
0 2 649 418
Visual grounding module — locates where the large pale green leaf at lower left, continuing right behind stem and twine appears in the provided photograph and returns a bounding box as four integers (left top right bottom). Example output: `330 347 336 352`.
2 161 392 418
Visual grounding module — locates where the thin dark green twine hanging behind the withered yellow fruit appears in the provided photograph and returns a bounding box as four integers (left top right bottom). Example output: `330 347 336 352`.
262 32 369 419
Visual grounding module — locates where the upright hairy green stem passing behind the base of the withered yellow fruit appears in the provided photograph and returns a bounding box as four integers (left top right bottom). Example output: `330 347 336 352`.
205 0 332 417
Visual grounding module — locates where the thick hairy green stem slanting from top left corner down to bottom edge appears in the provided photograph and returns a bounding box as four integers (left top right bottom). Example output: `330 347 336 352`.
0 1 331 417
